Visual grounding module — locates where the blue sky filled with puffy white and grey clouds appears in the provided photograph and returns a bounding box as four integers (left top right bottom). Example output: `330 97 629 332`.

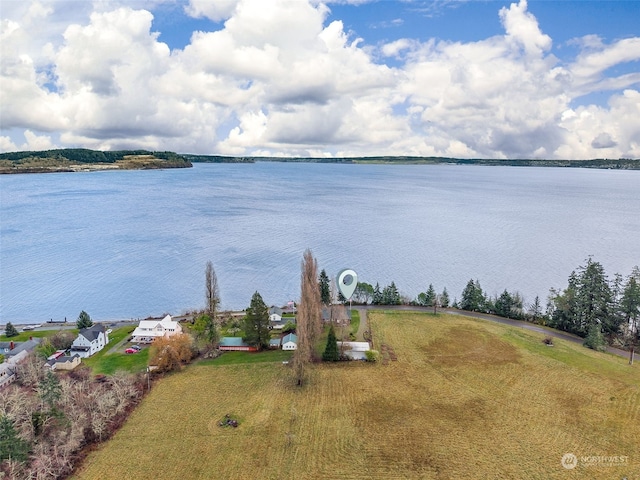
0 0 640 159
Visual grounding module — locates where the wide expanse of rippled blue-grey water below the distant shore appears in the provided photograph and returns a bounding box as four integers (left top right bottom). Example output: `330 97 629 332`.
0 162 640 323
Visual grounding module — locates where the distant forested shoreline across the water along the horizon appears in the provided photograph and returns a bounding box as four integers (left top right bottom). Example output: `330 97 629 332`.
0 148 640 174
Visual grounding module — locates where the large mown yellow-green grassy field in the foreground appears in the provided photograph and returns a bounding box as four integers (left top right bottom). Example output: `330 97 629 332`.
74 312 640 480
